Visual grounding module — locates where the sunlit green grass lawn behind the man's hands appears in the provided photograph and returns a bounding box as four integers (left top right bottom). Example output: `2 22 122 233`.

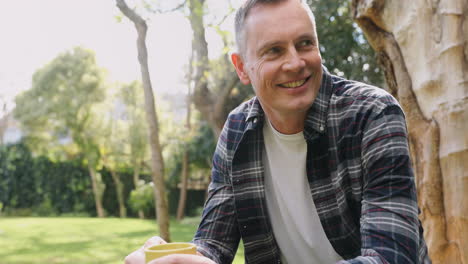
0 217 244 264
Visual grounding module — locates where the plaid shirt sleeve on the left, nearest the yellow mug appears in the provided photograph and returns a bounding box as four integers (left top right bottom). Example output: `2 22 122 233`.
193 120 240 264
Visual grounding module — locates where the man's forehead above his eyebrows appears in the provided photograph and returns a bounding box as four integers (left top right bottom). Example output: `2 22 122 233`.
244 0 316 49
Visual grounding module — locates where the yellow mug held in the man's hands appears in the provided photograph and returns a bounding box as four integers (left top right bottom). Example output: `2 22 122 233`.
145 242 197 263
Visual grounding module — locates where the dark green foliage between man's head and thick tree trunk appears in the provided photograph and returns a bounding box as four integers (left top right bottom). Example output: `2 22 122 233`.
308 0 384 86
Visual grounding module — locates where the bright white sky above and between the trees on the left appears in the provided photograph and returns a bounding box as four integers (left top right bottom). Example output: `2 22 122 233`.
0 0 239 115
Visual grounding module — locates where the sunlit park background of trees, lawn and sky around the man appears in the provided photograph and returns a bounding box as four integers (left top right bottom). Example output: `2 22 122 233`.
0 0 468 263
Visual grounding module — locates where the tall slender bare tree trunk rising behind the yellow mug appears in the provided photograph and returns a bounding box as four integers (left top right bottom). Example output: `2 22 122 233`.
116 0 170 242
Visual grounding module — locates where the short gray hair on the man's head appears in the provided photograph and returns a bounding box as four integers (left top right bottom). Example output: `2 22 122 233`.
234 0 315 54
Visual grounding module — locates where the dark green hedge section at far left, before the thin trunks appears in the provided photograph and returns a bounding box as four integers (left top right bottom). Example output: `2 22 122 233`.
0 143 94 215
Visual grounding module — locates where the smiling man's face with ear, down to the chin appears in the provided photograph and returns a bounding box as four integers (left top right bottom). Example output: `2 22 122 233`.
232 0 322 121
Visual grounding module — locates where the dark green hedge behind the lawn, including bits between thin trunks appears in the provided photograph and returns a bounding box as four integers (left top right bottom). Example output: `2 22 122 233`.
0 142 150 216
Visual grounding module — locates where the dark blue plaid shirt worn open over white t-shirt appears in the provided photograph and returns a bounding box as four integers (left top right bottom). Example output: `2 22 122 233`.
193 69 430 264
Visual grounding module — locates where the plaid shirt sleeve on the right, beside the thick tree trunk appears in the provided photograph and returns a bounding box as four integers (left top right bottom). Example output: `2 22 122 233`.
339 99 429 264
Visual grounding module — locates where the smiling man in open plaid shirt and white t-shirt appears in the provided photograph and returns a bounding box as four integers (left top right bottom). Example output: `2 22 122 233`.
127 0 430 264
